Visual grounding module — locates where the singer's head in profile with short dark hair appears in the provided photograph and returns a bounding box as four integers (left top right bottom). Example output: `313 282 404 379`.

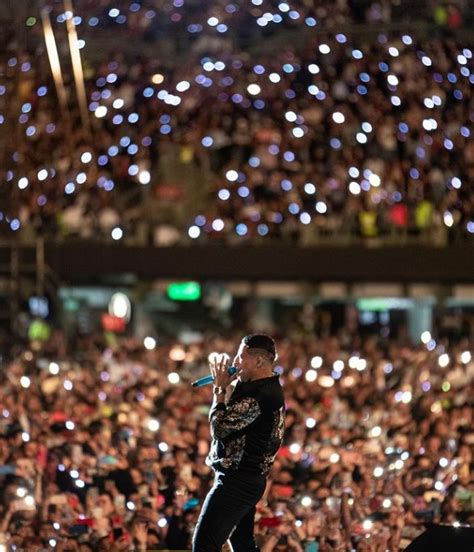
233 334 277 381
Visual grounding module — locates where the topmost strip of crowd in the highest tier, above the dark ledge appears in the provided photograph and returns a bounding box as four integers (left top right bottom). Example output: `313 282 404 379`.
8 0 456 45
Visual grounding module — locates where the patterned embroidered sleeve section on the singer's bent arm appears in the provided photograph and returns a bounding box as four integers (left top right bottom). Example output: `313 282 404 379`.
211 397 261 439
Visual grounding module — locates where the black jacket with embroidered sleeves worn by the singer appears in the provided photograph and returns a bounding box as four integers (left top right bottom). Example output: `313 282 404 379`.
206 375 285 475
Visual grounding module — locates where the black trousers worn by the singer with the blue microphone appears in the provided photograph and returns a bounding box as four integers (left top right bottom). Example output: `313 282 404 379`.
193 472 266 552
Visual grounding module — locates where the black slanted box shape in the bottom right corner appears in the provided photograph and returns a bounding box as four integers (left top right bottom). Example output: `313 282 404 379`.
405 525 474 552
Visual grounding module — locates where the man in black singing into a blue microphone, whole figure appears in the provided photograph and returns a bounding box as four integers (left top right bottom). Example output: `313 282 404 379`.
193 334 285 552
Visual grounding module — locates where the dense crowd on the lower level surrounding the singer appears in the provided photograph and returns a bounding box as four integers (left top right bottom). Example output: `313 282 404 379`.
0 322 474 552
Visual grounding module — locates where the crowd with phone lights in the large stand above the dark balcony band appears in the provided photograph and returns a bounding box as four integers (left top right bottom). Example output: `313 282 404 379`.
0 0 474 245
